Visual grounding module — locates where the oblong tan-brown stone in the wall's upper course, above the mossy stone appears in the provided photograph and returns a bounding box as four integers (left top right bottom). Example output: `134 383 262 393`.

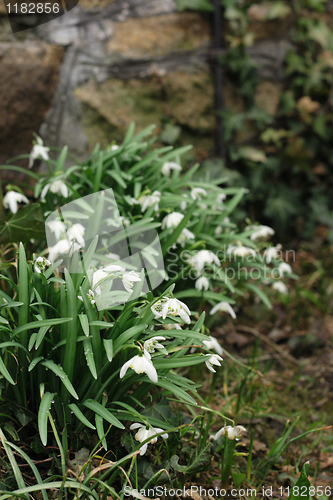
106 12 211 60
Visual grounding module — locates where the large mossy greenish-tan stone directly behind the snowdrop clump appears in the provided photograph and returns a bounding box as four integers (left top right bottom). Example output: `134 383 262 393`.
74 67 214 139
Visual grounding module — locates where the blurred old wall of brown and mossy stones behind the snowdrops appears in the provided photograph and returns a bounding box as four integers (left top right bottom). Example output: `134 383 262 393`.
0 0 291 175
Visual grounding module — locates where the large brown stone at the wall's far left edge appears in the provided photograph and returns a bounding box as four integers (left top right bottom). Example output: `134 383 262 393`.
0 42 63 180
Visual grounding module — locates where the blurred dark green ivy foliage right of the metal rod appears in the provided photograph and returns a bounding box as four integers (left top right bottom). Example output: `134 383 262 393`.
177 0 333 242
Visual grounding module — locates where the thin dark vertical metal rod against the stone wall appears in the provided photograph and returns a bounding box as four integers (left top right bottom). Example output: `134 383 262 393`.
213 0 225 160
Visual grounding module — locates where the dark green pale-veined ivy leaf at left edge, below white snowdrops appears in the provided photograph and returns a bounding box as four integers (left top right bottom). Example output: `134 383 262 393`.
0 203 45 243
